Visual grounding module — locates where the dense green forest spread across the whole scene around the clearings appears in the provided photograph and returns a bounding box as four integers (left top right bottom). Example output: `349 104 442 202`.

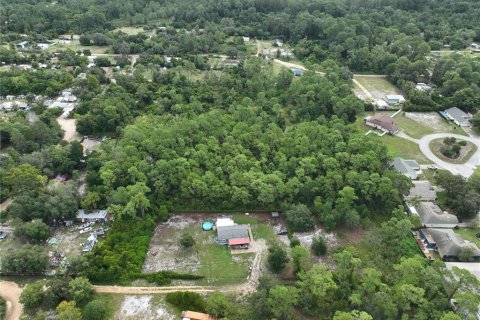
0 0 480 320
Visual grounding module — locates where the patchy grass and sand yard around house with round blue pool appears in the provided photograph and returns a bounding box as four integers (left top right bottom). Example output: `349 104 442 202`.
143 214 266 285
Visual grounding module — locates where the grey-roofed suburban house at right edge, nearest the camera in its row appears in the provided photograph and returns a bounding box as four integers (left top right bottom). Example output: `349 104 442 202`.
420 229 480 261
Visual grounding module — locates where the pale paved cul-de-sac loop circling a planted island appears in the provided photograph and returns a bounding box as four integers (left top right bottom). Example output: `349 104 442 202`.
397 132 480 178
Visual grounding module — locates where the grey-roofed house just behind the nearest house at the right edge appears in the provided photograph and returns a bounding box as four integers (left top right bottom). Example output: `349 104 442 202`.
407 202 458 229
